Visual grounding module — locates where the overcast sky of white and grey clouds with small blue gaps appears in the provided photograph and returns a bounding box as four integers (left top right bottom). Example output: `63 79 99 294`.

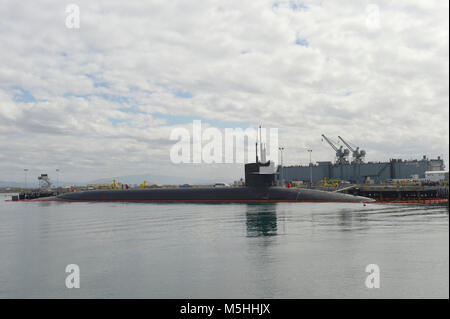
0 0 449 181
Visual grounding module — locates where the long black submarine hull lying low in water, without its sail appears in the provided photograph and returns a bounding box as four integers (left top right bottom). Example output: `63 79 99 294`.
54 187 373 203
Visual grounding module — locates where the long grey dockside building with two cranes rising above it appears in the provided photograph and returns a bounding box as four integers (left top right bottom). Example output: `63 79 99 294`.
278 135 445 184
